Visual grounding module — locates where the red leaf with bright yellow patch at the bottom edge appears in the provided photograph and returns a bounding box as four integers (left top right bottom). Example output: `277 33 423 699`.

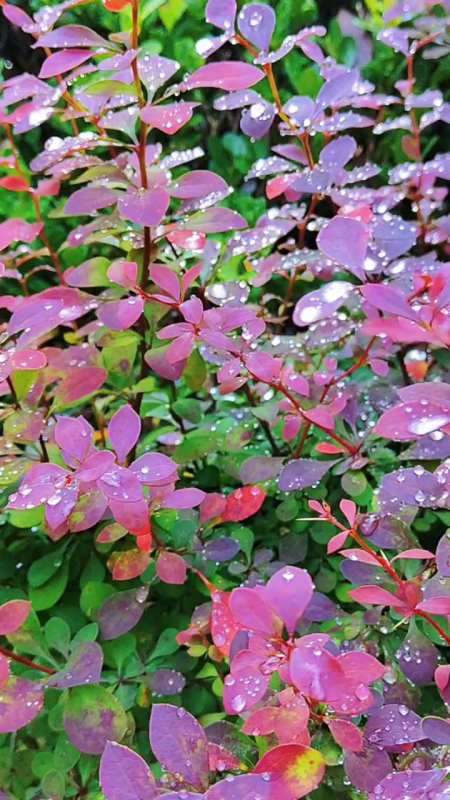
254 744 325 800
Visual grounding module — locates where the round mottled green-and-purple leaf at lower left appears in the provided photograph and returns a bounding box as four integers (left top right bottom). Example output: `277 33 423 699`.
64 686 128 755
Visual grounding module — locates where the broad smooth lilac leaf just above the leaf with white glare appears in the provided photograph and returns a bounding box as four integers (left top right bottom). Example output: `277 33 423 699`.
317 216 369 270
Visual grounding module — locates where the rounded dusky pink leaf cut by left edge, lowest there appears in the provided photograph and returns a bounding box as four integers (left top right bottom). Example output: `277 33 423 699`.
0 677 44 733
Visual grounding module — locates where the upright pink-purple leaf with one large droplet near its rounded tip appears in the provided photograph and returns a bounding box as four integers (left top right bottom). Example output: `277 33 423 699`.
265 567 314 634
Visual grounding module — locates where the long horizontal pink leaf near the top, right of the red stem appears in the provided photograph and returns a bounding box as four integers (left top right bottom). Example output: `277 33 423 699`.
181 61 264 92
